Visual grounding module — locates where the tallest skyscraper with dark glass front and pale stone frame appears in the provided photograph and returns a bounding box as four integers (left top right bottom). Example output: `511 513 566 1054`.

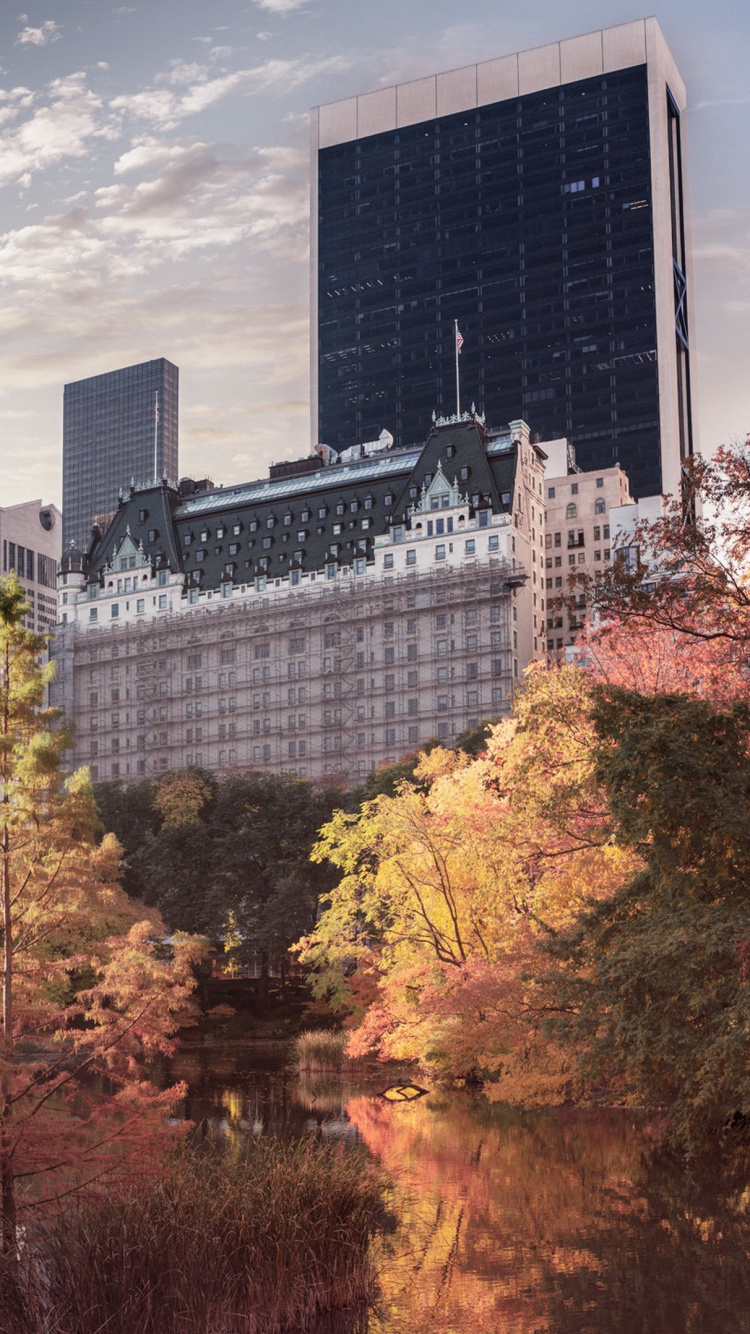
311 19 694 496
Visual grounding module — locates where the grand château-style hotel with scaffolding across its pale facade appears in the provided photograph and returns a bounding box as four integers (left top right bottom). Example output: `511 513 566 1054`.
55 414 546 783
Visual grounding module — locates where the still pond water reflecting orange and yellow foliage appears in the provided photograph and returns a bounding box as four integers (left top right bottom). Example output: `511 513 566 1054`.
173 1042 750 1334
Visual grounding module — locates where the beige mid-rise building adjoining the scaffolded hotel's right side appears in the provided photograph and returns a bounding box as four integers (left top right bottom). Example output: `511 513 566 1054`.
544 440 629 658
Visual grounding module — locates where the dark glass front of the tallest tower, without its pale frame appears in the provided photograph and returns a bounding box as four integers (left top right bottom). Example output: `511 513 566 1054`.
318 65 661 495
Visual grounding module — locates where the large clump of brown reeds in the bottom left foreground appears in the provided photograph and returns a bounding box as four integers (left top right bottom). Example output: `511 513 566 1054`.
0 1139 382 1334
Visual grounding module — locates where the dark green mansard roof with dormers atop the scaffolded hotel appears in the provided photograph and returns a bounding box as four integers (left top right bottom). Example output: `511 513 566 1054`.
83 414 518 588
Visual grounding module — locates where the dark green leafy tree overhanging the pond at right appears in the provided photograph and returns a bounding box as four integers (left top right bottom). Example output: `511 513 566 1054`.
552 687 750 1149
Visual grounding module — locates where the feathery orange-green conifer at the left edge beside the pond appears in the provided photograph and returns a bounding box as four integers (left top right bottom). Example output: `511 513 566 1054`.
0 575 202 1257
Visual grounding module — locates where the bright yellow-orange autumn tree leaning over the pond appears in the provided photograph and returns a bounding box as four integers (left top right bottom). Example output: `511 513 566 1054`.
300 668 627 1101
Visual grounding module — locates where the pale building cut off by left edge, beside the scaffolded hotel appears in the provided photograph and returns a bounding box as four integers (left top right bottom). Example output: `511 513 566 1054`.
0 500 63 635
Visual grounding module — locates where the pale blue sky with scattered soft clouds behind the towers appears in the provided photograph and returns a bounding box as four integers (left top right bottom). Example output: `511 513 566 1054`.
0 0 750 506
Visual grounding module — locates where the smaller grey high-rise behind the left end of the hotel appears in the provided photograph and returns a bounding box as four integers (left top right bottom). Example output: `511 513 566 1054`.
63 356 179 551
